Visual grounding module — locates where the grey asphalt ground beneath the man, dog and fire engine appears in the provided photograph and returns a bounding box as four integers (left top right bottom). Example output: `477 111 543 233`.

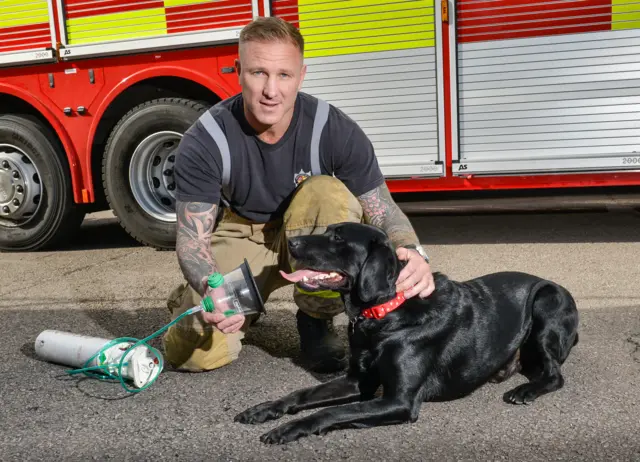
0 211 640 461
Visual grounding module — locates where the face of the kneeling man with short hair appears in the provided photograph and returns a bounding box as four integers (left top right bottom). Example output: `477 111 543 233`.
236 42 306 131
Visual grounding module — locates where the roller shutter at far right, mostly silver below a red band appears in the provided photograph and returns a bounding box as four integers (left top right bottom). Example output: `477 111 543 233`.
454 0 640 173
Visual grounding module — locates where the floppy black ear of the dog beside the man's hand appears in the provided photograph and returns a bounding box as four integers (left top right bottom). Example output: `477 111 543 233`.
357 243 397 303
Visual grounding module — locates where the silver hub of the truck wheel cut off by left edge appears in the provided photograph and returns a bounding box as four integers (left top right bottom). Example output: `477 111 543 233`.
0 145 42 221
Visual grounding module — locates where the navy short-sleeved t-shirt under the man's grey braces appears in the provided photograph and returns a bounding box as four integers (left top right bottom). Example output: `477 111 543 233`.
175 92 384 223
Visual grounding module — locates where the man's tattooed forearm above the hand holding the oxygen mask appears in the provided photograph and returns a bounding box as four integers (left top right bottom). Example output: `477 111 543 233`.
176 201 218 296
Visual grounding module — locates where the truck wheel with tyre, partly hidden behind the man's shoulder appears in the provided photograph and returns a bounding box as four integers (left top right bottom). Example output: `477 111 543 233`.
102 98 208 250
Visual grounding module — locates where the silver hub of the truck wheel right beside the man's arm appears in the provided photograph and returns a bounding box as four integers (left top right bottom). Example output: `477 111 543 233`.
129 131 182 222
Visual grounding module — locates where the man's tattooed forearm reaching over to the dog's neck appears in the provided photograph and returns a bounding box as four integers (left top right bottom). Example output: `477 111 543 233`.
358 183 420 247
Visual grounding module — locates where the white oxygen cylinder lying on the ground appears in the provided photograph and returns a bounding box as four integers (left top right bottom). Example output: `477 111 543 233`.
34 330 160 388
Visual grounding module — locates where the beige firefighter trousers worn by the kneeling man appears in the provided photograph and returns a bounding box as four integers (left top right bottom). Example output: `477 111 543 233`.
163 175 363 372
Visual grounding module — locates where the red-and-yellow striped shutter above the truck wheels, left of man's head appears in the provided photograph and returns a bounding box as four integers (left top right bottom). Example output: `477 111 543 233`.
59 0 264 59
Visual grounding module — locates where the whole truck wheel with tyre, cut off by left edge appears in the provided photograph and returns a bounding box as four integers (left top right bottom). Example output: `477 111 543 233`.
0 115 85 252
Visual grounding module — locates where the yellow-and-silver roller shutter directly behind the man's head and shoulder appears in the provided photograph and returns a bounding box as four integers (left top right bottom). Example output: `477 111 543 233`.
272 0 444 176
